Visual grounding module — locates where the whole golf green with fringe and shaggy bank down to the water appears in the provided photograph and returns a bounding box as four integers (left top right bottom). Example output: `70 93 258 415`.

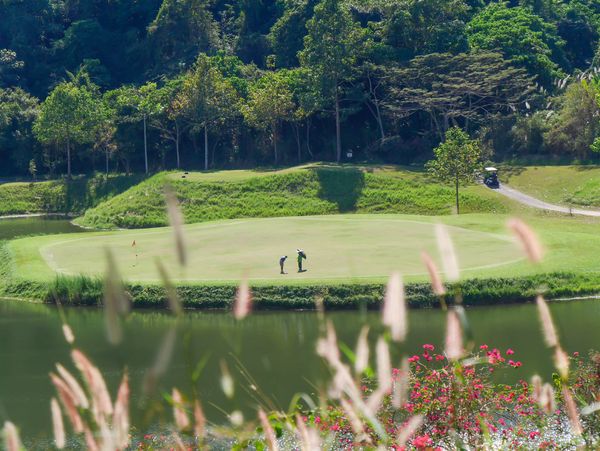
0 214 600 308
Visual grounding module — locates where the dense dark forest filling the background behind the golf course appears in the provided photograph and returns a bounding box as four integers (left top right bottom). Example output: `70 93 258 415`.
0 0 600 177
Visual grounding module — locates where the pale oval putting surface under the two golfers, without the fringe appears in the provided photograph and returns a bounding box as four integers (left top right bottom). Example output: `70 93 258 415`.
32 215 520 282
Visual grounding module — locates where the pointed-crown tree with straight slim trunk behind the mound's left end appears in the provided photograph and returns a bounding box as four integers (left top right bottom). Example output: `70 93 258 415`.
176 54 240 170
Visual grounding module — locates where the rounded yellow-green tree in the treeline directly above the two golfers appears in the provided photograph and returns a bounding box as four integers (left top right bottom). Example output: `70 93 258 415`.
243 72 294 165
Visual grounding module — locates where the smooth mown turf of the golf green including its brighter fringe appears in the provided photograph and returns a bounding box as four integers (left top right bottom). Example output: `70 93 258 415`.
9 214 600 284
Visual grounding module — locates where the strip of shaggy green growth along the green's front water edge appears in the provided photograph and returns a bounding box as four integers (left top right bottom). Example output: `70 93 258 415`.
0 273 600 310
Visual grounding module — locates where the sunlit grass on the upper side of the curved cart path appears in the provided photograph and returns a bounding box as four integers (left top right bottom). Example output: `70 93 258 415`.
501 166 600 207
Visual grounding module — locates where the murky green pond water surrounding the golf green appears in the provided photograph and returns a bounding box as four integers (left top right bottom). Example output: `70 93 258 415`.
0 218 600 449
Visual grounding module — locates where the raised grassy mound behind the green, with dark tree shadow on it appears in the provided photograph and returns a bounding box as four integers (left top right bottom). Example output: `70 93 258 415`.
77 165 508 228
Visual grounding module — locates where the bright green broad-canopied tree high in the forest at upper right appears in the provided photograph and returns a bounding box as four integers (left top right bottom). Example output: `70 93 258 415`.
467 3 568 87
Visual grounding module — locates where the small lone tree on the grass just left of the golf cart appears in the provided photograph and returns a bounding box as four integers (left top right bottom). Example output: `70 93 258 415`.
426 127 481 214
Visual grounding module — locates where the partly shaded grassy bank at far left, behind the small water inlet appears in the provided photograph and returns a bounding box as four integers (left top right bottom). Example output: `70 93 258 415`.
0 175 142 216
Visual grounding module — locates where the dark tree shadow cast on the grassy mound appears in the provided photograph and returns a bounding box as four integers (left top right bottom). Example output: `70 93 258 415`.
313 167 365 212
